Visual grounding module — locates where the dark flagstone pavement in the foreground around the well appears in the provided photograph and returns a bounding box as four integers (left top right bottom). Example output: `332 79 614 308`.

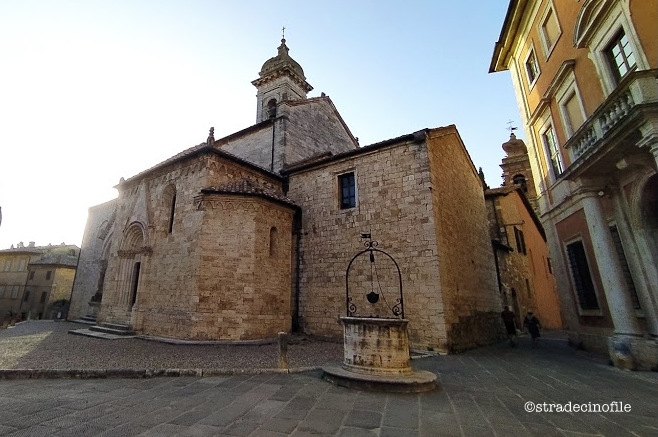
0 320 658 437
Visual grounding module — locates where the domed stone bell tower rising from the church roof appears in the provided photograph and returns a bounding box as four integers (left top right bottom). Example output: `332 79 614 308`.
251 33 313 123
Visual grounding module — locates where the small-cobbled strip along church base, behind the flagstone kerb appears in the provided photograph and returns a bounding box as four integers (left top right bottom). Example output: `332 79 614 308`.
0 320 343 370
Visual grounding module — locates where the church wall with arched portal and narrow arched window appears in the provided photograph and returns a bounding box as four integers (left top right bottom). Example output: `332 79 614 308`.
99 157 207 328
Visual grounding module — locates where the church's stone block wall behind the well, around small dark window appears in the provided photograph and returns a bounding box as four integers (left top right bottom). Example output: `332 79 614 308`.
288 135 447 349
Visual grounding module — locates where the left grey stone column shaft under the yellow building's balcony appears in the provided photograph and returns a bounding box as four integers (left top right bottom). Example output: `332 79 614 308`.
581 192 642 336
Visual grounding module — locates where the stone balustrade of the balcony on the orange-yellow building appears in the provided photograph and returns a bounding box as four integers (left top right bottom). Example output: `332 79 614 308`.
564 69 658 162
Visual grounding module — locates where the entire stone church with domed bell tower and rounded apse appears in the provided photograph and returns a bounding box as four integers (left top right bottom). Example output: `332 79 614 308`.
68 36 502 351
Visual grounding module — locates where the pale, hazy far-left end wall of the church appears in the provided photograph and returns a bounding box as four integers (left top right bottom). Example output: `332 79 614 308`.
67 200 117 320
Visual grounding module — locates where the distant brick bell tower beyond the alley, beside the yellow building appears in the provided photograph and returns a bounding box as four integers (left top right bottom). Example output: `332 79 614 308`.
500 132 537 210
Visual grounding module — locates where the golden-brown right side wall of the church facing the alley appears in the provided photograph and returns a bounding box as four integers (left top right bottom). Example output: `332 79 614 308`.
427 126 502 350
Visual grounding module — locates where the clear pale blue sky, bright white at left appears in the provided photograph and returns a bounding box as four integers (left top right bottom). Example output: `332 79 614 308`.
0 0 520 249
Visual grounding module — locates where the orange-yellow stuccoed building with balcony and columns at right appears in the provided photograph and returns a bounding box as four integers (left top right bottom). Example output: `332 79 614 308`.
490 0 658 369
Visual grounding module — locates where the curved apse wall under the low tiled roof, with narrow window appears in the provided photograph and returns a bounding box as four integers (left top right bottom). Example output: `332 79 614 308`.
193 194 294 340
